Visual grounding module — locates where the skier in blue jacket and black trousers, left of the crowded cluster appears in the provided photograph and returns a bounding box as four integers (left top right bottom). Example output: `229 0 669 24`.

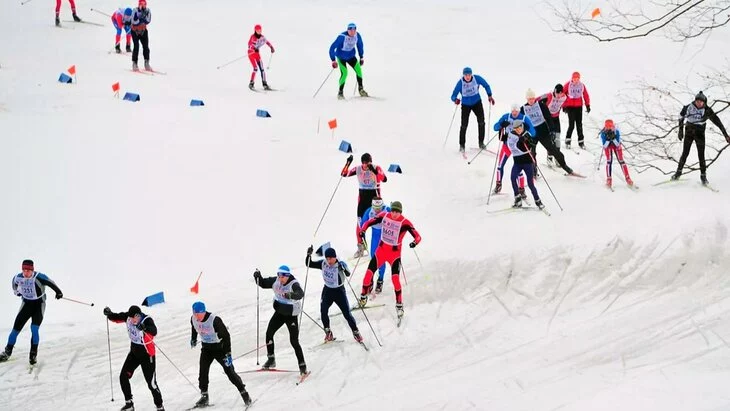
451 67 494 153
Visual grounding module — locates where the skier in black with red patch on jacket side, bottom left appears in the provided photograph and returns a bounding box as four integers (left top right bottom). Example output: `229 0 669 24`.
104 305 165 411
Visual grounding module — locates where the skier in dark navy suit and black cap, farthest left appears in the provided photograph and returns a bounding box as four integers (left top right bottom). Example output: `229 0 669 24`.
0 260 63 365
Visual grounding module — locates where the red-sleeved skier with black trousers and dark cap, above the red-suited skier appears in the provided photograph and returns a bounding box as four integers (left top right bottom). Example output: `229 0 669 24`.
340 153 388 257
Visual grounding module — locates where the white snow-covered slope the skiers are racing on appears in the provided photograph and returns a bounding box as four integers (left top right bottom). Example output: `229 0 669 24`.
0 0 730 410
